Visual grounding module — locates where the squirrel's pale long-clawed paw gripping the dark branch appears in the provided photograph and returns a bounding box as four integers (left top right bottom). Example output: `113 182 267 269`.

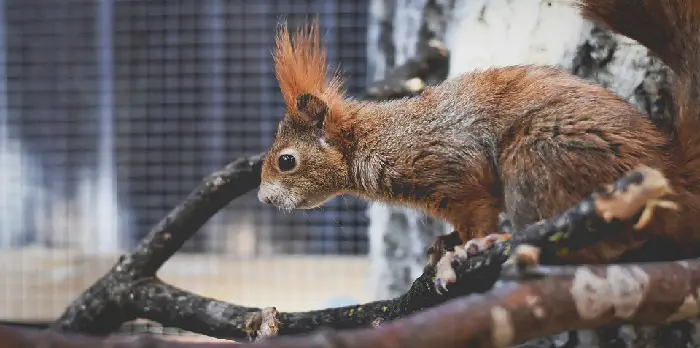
435 233 511 294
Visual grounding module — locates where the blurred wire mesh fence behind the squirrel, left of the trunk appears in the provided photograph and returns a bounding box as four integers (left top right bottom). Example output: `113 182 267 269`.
0 0 369 334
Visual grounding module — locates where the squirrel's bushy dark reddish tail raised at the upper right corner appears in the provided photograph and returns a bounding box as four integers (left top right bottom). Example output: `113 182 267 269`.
574 0 700 185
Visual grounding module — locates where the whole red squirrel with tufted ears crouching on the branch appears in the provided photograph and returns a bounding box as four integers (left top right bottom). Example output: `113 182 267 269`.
258 0 700 285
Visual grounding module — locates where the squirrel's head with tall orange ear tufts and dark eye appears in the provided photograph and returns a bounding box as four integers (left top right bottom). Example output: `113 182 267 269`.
258 23 349 210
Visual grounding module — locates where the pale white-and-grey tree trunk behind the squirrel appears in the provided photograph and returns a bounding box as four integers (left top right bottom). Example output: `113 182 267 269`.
368 0 700 347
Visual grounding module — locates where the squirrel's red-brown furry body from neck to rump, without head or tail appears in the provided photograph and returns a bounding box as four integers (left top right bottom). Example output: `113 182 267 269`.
353 65 671 237
